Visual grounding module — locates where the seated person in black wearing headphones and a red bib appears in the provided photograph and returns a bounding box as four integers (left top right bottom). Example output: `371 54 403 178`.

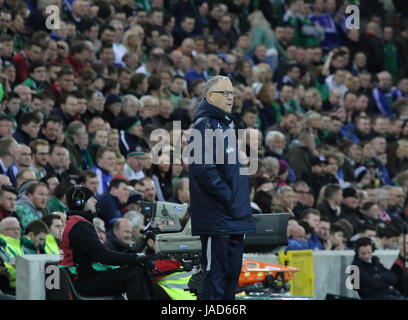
59 185 167 300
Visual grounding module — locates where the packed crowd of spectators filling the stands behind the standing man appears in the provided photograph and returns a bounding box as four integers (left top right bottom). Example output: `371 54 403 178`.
0 0 408 300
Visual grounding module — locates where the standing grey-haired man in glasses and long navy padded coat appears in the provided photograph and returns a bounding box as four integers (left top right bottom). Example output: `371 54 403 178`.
189 76 255 300
